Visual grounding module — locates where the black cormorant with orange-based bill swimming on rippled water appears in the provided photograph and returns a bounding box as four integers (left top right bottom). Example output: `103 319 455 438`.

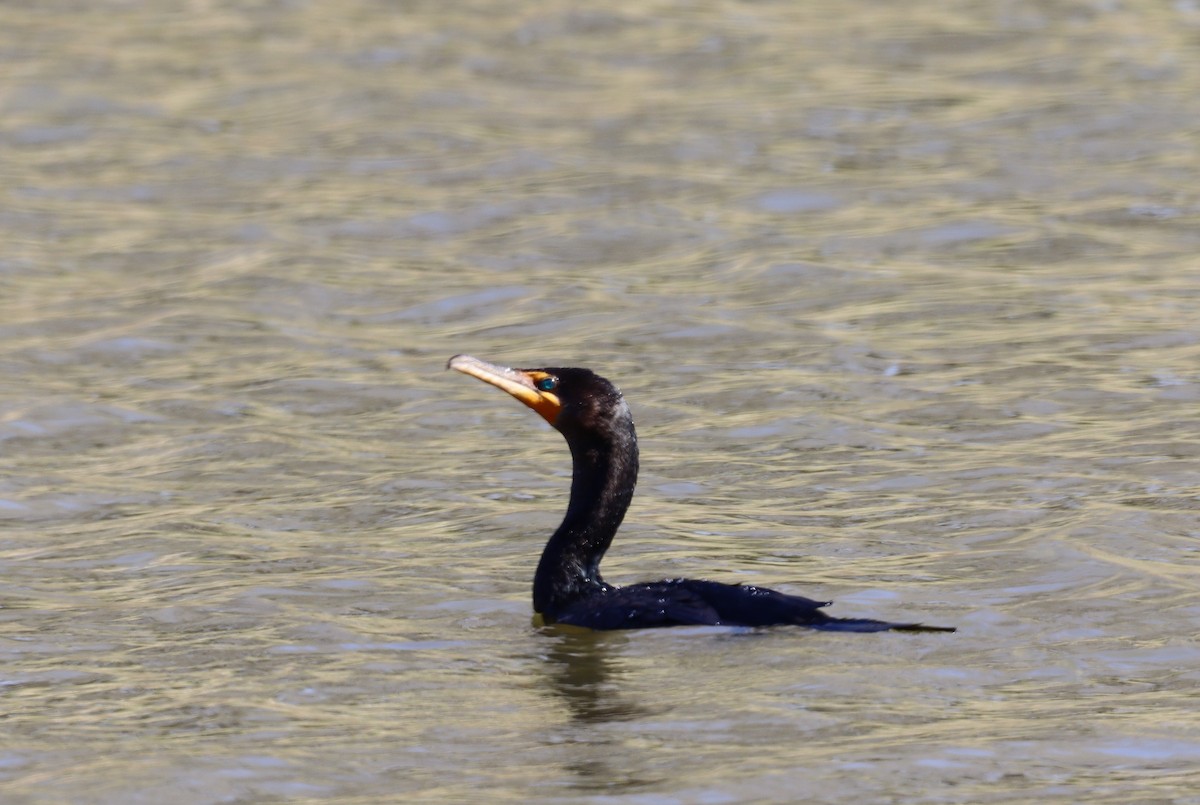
448 355 954 632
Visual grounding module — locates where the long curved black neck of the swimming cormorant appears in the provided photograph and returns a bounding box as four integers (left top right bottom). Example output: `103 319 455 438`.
533 400 637 620
